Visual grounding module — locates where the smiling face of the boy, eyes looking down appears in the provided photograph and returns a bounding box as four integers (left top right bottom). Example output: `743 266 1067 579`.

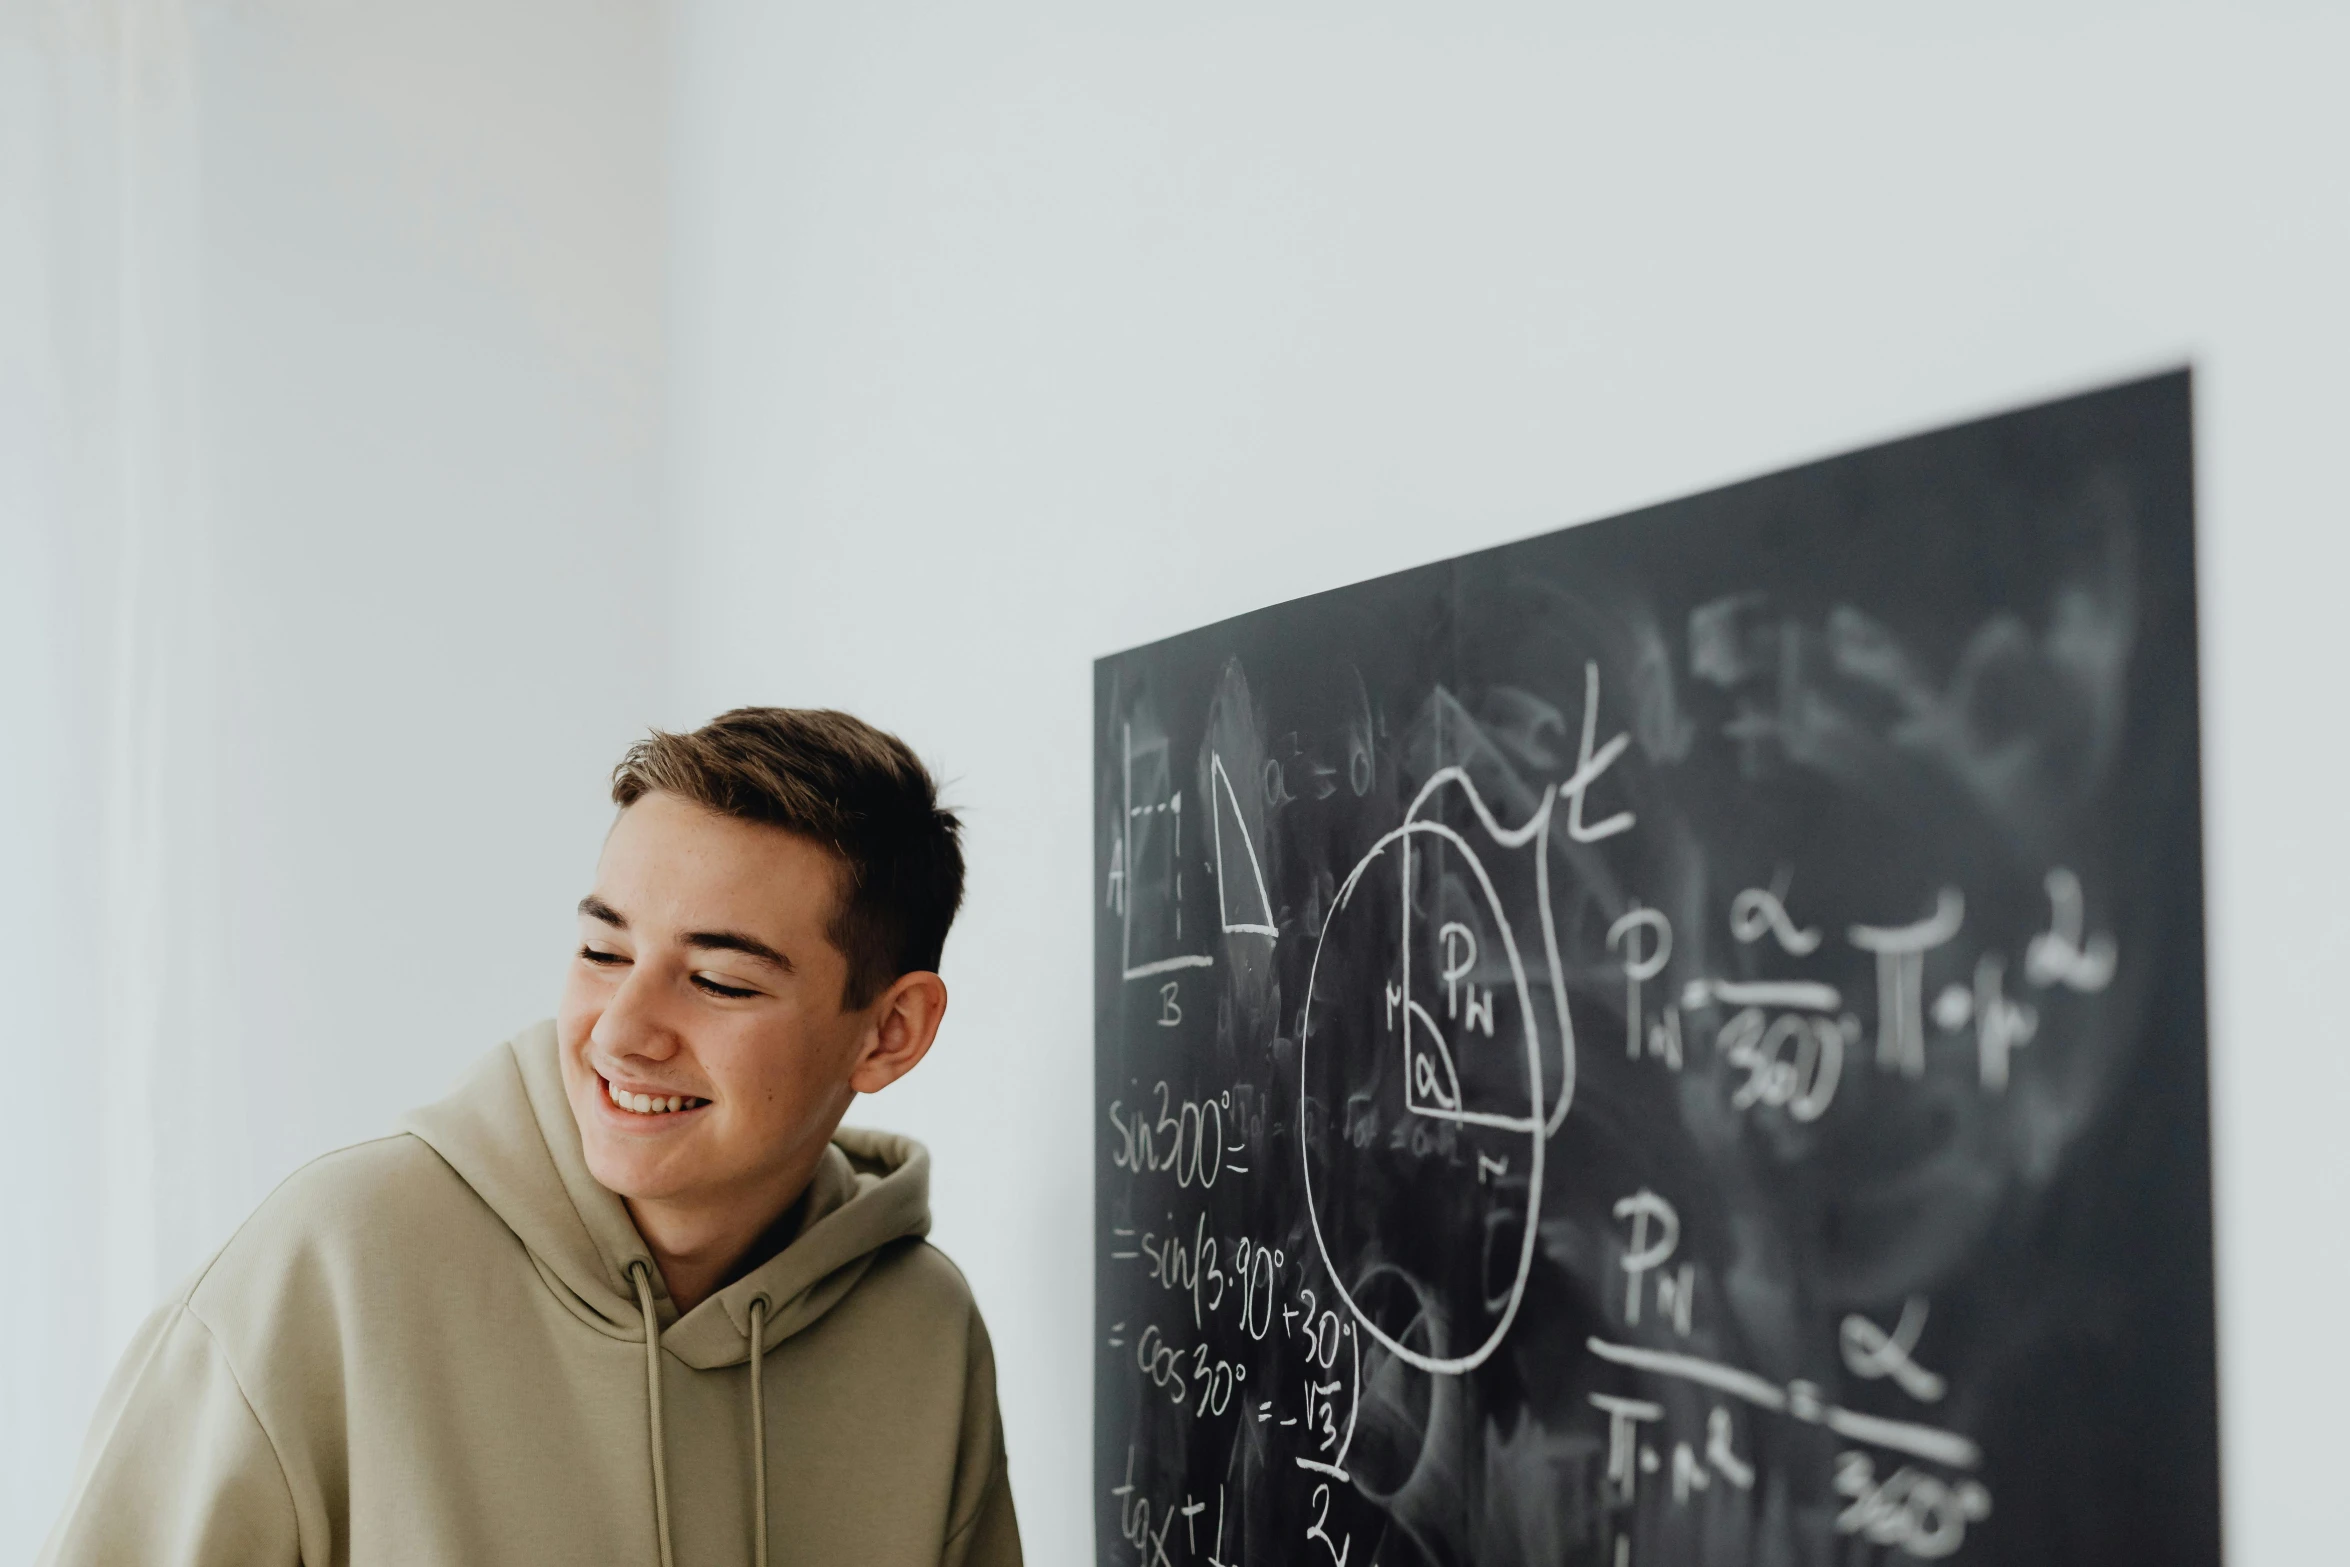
555 794 883 1222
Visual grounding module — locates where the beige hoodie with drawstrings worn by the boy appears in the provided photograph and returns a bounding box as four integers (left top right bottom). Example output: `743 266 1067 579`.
42 1024 1020 1567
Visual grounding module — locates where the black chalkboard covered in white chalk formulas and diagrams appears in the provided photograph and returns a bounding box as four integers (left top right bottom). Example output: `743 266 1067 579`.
1095 371 2218 1567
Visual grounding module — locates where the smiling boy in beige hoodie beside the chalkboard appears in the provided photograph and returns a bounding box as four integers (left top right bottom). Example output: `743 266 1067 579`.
42 707 1020 1567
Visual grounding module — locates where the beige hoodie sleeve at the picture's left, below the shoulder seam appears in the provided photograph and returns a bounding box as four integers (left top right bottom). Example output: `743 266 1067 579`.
40 1302 301 1567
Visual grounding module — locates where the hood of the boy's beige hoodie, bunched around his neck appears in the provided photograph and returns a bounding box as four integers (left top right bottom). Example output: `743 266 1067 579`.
402 1022 931 1370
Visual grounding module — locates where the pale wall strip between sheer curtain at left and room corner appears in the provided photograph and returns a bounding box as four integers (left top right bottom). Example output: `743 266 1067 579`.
197 0 667 1182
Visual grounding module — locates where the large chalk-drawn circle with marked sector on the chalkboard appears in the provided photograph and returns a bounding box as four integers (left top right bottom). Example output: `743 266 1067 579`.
1297 803 1572 1374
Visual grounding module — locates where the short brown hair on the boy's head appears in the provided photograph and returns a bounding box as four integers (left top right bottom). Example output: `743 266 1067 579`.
611 707 964 1010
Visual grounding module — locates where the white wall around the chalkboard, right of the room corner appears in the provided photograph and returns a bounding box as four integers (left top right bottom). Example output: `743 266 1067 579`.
670 0 2350 1567
